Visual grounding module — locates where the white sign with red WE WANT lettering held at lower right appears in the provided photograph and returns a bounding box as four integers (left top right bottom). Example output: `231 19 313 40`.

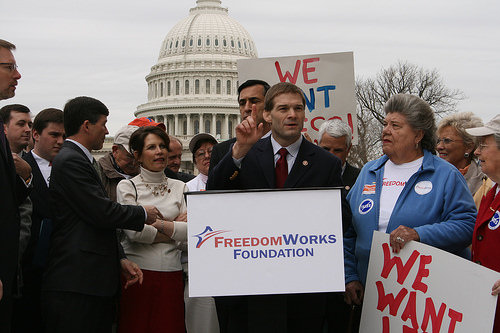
360 231 500 333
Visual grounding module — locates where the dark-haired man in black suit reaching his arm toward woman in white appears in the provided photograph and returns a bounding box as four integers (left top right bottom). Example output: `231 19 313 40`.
42 97 161 333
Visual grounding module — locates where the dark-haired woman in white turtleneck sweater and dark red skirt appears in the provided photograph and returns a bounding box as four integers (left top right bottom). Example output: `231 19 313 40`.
117 126 187 333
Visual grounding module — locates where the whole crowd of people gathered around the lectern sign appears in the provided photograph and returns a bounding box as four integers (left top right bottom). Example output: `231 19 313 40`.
0 36 500 333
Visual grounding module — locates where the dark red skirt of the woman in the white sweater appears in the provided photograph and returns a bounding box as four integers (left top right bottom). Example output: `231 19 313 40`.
118 269 185 333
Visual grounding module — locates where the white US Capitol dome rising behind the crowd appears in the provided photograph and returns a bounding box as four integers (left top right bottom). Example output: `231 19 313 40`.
135 0 257 172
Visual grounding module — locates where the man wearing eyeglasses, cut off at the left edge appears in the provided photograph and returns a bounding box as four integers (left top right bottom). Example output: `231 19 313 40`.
0 39 28 332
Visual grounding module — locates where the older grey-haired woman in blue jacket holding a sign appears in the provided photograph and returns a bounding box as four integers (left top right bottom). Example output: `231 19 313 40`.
344 94 476 304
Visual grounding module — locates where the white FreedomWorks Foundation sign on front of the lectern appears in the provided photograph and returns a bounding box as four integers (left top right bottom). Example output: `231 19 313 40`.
188 189 344 297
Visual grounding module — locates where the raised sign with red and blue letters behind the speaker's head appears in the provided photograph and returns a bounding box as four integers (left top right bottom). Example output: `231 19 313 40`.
238 52 357 144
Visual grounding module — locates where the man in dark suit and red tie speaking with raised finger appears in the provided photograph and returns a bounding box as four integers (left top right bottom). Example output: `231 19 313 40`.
207 83 350 333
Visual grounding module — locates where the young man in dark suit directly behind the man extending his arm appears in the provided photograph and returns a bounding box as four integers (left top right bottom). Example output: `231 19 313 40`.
12 109 64 333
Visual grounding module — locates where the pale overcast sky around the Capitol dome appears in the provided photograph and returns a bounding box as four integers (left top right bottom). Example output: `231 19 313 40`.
0 0 500 134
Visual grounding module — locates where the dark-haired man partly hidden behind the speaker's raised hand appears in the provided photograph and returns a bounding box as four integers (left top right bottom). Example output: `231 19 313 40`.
210 80 271 170
